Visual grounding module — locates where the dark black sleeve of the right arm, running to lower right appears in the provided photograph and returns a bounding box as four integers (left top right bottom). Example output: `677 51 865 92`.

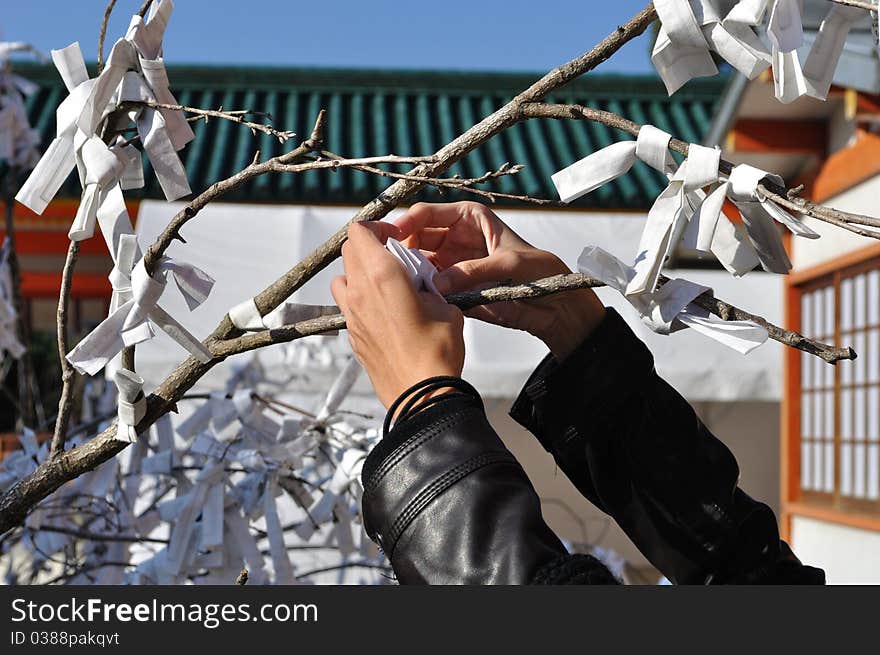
511 309 824 584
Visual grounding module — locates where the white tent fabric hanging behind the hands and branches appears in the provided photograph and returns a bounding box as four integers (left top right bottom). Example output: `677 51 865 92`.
137 201 782 401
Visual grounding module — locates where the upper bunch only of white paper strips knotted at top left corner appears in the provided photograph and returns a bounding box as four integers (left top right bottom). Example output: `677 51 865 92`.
16 0 192 238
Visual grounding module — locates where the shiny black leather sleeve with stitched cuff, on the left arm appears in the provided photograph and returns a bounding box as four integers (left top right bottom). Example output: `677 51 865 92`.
361 394 615 584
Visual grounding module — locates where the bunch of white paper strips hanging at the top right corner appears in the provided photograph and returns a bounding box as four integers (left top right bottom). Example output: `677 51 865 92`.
651 0 866 103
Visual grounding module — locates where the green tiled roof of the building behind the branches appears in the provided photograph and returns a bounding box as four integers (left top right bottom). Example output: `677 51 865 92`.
16 64 725 209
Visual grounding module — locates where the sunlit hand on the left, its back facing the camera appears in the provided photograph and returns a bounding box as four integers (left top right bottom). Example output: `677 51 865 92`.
330 223 464 407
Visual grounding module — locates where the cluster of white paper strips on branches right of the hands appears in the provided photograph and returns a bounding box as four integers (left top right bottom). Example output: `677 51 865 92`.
553 125 819 353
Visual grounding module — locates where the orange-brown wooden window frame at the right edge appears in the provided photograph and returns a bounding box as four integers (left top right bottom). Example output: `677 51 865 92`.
780 244 880 540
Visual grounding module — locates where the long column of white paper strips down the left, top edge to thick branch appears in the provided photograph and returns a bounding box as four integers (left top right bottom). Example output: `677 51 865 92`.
10 0 222 439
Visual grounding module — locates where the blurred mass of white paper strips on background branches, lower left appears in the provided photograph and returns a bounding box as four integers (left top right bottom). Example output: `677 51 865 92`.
0 357 392 584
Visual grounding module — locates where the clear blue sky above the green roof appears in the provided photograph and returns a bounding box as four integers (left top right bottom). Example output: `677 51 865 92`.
0 0 651 72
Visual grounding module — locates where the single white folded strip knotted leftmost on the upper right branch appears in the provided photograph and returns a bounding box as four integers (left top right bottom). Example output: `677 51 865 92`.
551 125 675 203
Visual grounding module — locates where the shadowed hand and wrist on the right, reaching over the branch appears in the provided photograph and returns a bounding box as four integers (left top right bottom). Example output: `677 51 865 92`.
394 202 605 360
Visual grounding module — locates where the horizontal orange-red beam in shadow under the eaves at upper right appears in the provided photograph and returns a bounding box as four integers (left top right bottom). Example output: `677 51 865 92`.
728 118 828 157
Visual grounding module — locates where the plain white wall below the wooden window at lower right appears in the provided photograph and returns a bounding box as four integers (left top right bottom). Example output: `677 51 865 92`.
791 516 880 584
